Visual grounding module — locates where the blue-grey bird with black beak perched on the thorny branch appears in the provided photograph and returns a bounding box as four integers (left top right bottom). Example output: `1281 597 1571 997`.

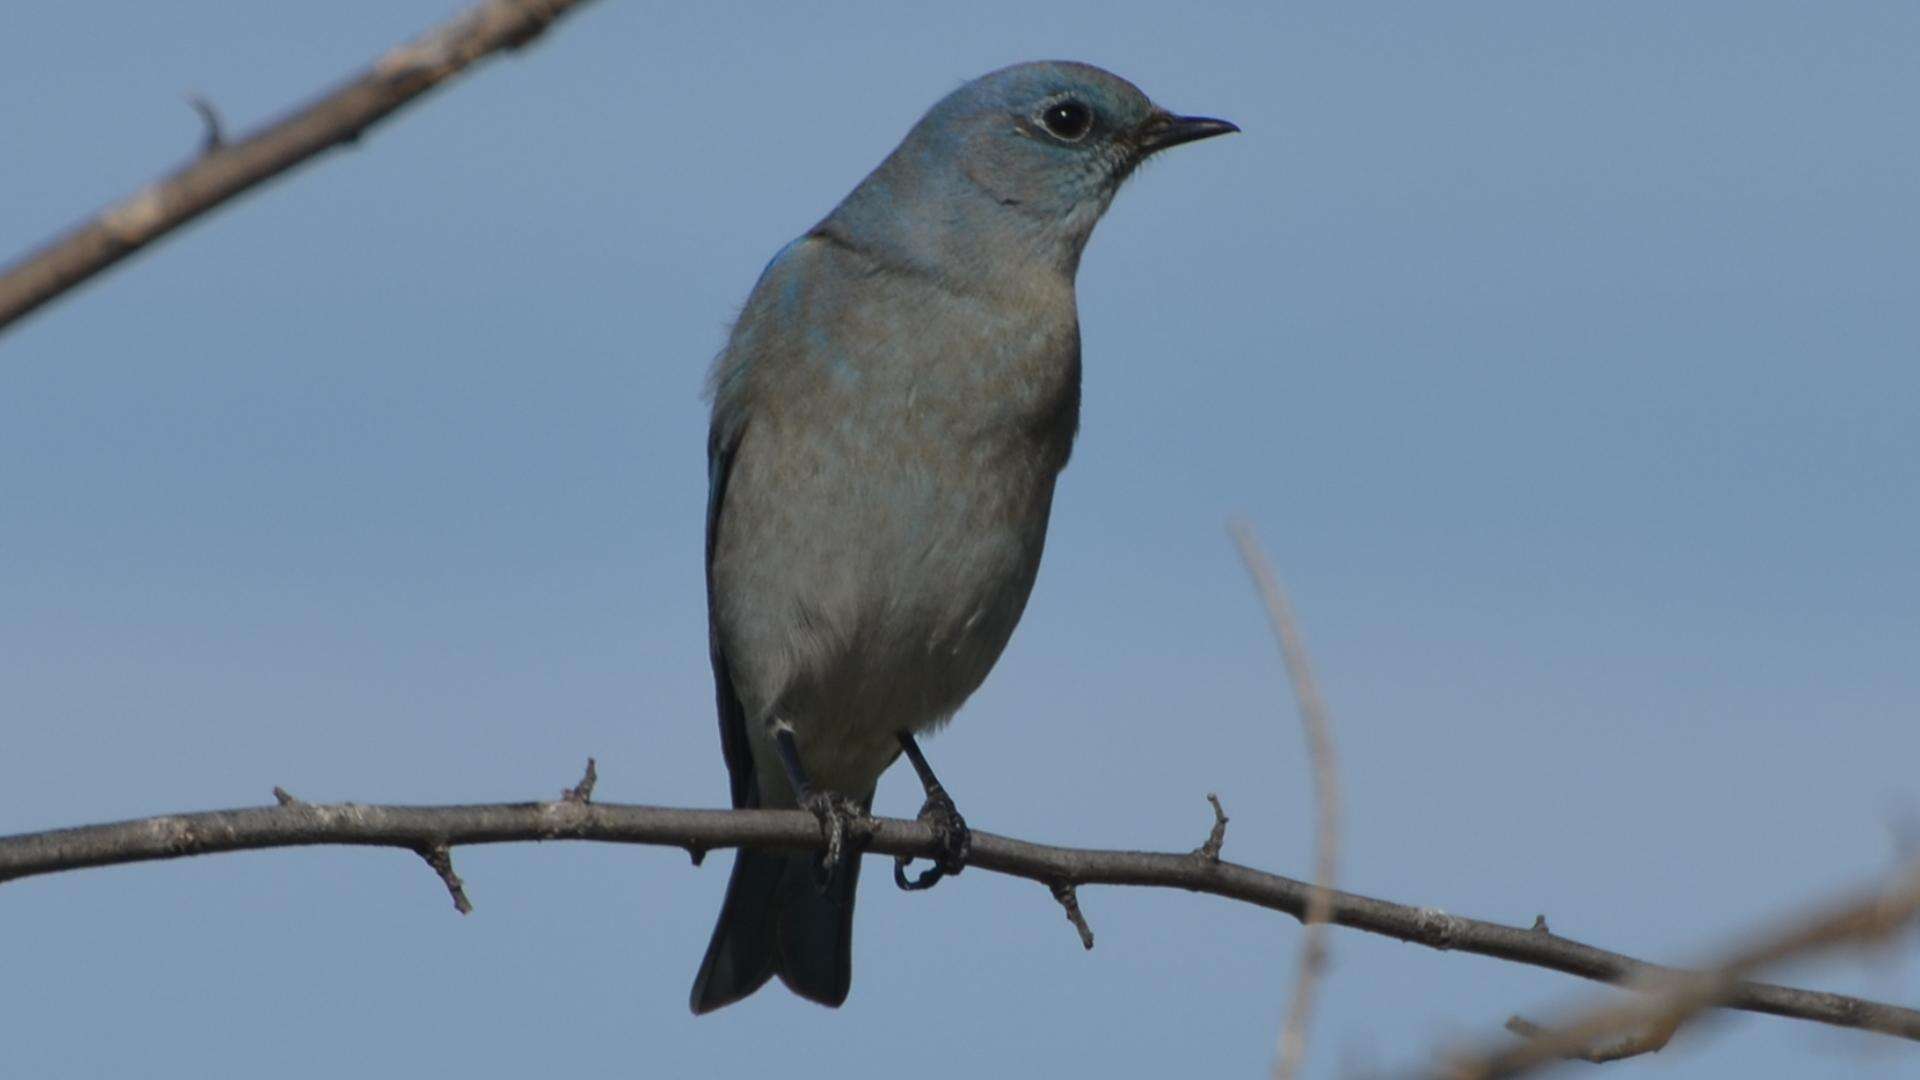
691 61 1238 1013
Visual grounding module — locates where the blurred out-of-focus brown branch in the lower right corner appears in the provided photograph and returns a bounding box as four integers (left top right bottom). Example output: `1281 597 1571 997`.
1440 863 1920 1080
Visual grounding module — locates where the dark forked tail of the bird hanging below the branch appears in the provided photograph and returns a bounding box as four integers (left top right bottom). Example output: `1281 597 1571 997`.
691 849 860 1015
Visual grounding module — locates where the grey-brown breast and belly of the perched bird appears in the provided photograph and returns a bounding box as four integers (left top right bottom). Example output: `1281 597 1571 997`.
712 242 1079 790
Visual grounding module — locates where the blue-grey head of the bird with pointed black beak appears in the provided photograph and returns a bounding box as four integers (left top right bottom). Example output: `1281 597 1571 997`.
829 61 1240 275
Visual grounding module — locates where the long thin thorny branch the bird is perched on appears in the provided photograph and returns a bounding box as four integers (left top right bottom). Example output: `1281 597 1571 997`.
0 772 1920 1042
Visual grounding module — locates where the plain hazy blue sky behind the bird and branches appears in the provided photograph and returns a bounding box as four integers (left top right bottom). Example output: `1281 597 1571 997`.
0 0 1920 1080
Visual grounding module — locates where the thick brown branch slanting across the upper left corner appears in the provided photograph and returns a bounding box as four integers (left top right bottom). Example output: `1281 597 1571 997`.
0 0 586 331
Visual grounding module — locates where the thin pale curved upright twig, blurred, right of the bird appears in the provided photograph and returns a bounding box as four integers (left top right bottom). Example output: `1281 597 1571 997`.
1227 521 1340 1080
